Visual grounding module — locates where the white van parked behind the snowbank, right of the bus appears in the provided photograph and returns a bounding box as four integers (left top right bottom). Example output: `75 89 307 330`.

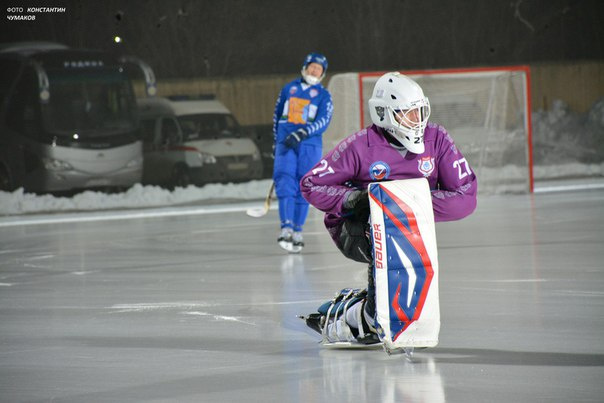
138 96 263 188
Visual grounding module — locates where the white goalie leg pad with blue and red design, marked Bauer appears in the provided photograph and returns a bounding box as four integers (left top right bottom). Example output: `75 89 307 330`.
369 178 440 351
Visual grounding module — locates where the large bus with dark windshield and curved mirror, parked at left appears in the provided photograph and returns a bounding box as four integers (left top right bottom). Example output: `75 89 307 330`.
0 43 155 193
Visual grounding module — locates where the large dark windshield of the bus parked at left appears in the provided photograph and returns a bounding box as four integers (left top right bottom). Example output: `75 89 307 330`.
43 70 136 138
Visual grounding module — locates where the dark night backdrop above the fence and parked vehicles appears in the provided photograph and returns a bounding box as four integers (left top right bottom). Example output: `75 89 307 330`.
1 0 604 78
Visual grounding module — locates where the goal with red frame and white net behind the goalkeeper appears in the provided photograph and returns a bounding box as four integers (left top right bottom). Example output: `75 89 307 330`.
323 66 533 194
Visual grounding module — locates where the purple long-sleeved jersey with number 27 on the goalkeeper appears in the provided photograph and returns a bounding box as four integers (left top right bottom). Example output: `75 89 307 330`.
300 123 477 240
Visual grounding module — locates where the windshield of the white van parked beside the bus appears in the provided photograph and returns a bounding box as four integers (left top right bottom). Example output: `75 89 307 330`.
178 113 239 141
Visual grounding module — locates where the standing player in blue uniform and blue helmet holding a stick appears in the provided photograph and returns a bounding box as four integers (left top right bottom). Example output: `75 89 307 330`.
273 53 333 253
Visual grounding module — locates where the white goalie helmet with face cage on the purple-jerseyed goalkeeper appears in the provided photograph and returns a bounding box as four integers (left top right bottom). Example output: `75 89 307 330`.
369 72 430 154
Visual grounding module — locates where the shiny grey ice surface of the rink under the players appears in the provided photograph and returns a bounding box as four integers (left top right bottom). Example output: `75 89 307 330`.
0 189 604 403
